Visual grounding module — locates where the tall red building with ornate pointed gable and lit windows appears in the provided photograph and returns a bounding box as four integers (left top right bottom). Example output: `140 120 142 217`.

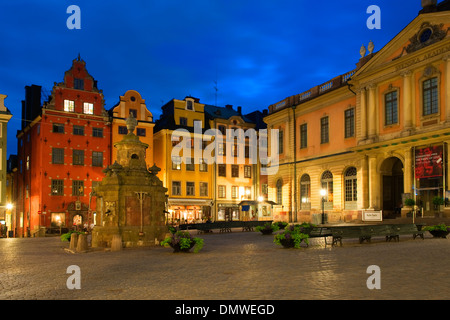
16 57 111 237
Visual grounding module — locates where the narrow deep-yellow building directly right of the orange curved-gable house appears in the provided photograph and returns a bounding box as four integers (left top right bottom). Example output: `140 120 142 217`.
153 97 213 223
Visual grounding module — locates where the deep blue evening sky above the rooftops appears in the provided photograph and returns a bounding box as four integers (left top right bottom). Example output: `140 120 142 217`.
0 0 421 155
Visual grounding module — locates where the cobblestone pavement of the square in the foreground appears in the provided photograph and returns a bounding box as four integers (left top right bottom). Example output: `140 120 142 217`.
0 230 450 300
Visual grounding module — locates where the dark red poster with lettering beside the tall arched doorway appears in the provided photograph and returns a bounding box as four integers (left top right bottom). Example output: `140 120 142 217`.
415 145 444 179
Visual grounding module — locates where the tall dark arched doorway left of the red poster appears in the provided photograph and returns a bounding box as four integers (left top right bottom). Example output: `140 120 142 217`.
380 157 403 219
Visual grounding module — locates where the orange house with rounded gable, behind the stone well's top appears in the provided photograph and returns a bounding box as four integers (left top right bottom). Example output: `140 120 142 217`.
109 90 155 167
